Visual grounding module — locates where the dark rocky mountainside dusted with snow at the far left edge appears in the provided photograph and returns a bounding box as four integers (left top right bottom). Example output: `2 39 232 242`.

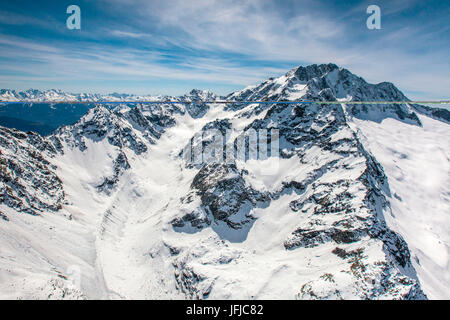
0 127 65 215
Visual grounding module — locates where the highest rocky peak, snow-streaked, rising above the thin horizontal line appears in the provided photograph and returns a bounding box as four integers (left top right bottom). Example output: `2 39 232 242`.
227 63 421 126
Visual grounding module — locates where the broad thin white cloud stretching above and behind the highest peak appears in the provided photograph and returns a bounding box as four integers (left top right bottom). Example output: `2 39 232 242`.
100 0 450 97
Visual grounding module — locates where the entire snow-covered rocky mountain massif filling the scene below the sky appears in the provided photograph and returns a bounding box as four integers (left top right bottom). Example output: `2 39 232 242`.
0 64 450 299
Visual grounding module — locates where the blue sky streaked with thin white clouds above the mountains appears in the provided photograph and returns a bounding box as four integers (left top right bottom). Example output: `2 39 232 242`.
0 0 450 99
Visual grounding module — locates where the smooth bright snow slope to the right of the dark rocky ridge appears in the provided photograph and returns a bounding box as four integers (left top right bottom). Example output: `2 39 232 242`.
352 116 450 299
